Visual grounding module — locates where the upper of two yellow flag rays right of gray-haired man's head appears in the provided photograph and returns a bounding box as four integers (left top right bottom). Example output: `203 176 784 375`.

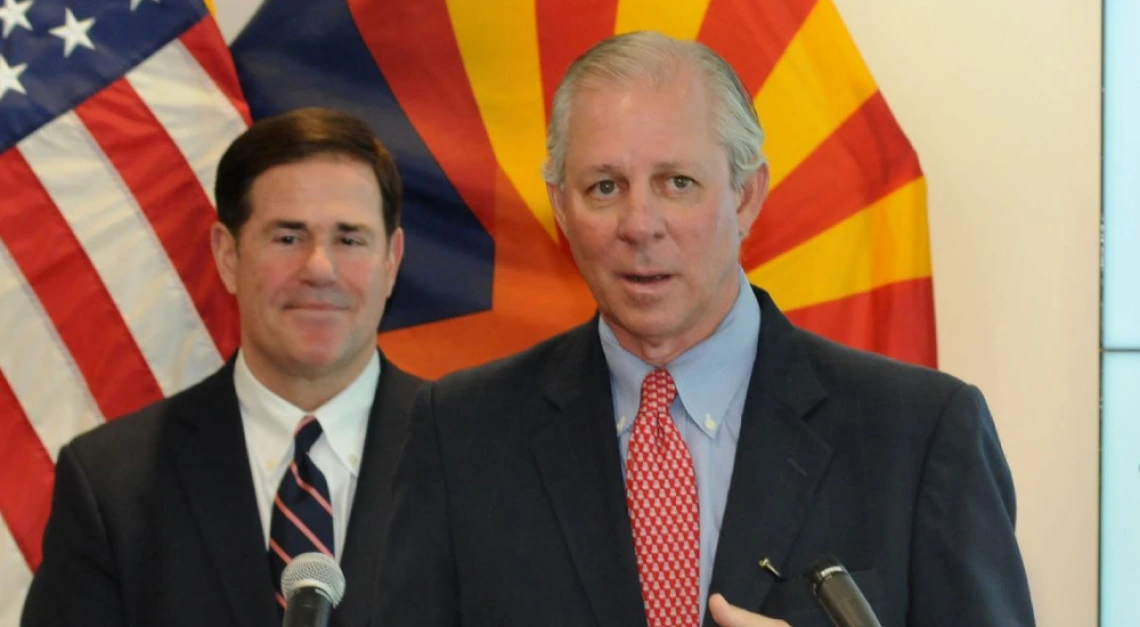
755 0 878 188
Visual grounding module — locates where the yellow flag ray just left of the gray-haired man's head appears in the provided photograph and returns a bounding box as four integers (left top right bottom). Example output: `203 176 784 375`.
447 0 557 241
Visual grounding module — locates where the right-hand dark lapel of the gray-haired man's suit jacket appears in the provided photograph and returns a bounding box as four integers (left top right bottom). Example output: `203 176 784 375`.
703 290 831 627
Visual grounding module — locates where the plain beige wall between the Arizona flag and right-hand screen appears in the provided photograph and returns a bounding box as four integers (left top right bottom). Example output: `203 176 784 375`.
834 0 1101 627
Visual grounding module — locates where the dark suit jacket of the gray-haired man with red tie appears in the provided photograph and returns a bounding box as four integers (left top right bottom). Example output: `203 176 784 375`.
373 291 1033 627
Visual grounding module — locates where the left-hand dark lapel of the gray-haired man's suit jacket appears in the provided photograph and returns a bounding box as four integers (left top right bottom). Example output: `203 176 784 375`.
531 318 645 627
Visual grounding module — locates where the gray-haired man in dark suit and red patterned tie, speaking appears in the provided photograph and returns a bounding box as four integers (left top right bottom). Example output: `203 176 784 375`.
374 33 1033 627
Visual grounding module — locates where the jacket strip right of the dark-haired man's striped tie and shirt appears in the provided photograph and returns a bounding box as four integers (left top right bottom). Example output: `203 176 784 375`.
331 355 420 627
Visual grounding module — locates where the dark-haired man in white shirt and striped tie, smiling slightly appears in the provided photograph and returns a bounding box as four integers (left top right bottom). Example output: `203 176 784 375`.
22 109 421 627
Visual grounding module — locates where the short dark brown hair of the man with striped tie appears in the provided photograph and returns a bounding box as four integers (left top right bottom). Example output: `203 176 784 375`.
214 107 404 237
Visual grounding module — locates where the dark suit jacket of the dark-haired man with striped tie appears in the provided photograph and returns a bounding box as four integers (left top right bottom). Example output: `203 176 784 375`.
21 351 421 627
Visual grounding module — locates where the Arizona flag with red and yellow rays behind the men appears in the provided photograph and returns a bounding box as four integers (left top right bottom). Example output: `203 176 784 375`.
231 0 936 376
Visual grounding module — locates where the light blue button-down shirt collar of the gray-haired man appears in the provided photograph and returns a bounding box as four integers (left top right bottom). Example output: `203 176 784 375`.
599 270 760 437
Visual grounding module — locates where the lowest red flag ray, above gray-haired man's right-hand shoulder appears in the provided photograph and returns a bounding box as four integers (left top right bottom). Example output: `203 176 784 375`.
788 277 938 368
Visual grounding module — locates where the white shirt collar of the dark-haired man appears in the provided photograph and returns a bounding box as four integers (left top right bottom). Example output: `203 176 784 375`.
234 350 380 477
